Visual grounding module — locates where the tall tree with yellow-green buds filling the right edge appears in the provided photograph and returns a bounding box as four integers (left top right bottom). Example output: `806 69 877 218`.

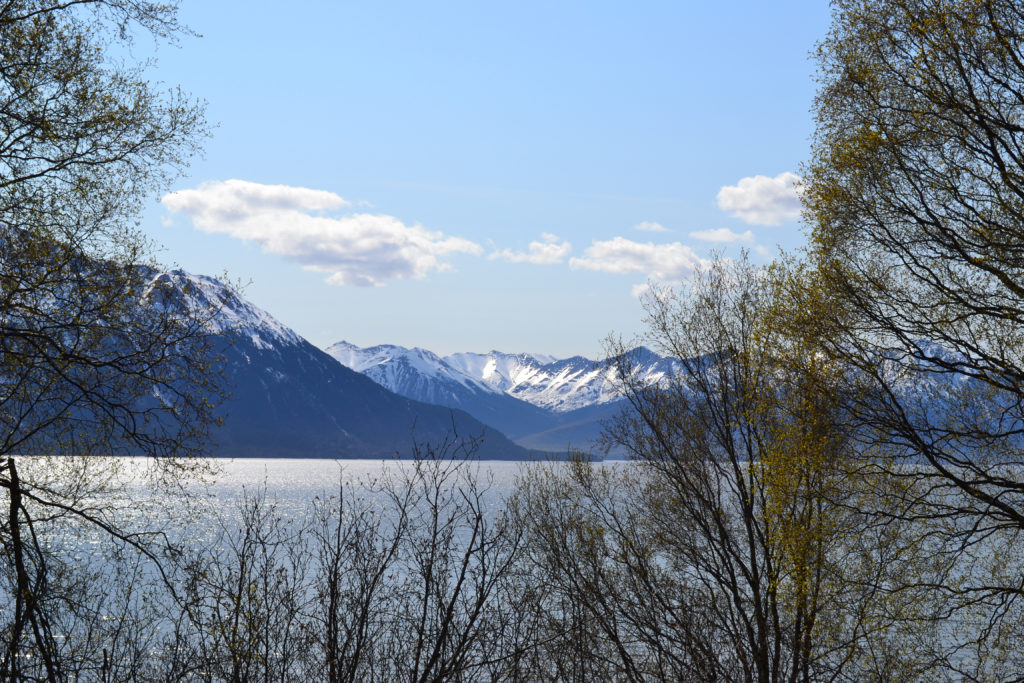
803 0 1024 663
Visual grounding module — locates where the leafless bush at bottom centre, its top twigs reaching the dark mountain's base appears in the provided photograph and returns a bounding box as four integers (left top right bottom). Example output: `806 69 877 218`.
325 438 527 682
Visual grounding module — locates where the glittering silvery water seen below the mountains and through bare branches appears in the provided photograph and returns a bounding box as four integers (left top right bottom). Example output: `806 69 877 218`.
8 459 1019 680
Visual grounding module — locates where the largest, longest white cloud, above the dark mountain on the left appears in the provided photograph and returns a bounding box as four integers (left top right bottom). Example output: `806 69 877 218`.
161 180 482 286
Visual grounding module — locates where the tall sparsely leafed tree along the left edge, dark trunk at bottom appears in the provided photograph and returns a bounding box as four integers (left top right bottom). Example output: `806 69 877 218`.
0 0 217 680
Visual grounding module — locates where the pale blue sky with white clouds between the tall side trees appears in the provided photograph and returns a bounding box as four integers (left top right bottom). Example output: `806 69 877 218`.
142 0 829 358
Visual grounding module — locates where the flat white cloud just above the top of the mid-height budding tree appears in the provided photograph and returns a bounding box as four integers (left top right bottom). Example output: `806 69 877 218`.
569 238 709 283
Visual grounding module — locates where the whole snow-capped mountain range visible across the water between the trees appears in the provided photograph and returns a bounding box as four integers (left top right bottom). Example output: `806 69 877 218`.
155 270 673 460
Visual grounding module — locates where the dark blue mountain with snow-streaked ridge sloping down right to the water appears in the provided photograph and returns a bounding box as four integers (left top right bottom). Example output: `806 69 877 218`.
158 270 528 459
